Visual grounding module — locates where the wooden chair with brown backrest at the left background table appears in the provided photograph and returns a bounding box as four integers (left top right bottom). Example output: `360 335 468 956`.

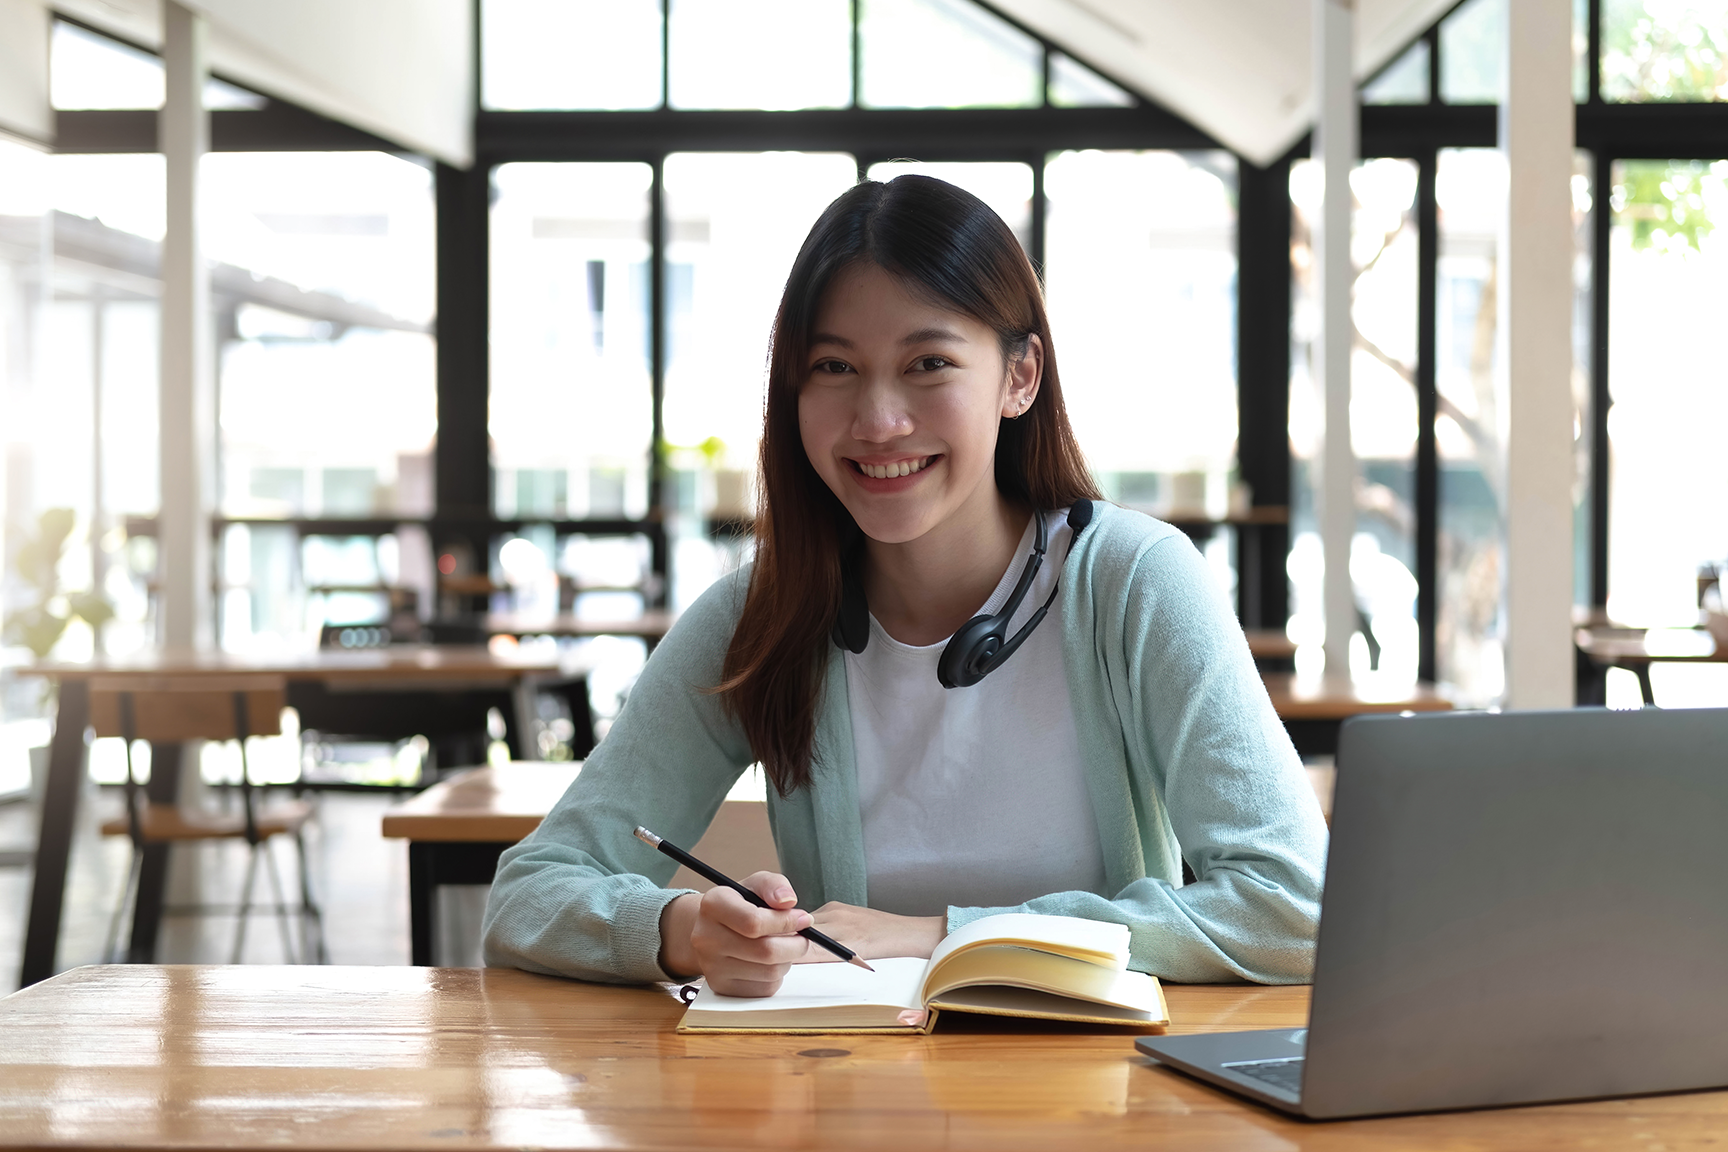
90 675 328 964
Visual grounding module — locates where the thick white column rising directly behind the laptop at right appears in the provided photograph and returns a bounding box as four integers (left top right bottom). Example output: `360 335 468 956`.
1498 0 1582 708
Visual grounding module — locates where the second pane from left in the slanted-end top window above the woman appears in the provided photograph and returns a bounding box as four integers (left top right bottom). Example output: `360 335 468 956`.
669 0 852 111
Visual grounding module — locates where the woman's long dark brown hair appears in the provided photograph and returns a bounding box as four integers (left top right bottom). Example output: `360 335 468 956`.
717 176 1097 796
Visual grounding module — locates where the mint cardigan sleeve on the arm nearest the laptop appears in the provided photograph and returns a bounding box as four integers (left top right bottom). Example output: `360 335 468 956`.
949 530 1327 983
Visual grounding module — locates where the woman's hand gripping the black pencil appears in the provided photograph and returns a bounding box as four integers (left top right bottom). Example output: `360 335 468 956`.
660 872 810 997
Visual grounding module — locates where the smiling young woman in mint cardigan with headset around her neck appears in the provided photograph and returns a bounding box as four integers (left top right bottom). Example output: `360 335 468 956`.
486 176 1325 995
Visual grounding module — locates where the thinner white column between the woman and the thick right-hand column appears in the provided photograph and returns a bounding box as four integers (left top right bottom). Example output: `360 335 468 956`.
1313 0 1356 675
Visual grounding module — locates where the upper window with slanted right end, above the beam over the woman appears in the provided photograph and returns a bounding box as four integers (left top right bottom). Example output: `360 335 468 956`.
480 0 1135 111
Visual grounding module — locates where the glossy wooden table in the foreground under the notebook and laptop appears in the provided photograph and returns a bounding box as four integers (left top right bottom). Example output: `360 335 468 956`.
0 965 1728 1152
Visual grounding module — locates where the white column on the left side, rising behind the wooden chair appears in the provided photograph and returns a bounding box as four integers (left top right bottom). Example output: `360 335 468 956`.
157 0 216 648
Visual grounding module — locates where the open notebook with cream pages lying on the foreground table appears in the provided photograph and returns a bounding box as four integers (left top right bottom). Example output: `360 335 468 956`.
677 912 1170 1033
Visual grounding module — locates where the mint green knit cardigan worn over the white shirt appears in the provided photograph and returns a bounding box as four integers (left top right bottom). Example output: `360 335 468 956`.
484 503 1325 983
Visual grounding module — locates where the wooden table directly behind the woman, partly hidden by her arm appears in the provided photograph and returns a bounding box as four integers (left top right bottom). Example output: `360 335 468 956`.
382 762 779 965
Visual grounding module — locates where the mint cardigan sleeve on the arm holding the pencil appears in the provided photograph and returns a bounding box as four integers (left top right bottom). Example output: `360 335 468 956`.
482 573 752 983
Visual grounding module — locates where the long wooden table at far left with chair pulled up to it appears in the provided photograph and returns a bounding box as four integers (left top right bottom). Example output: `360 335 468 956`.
17 644 558 986
